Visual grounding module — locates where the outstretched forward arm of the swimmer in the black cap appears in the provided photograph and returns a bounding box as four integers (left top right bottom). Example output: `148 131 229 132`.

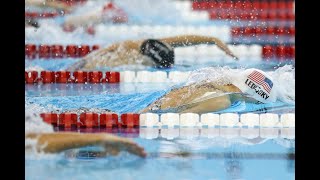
160 35 239 60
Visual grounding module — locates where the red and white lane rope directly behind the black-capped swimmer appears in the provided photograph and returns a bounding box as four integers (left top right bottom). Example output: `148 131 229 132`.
25 44 295 60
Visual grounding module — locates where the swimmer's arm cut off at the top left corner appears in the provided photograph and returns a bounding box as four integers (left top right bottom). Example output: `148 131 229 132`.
25 0 72 11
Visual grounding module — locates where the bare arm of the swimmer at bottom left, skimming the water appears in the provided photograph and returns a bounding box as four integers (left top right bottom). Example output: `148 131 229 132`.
26 132 146 157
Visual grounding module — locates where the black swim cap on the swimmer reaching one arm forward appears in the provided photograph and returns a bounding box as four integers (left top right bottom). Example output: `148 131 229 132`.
140 39 174 68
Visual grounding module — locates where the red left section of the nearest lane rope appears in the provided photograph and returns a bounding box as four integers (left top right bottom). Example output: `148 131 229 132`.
40 112 134 129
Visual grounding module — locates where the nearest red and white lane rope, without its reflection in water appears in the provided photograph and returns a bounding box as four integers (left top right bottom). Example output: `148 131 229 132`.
40 112 295 128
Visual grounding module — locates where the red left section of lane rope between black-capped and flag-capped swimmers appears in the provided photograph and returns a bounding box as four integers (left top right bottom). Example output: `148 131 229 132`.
25 71 120 84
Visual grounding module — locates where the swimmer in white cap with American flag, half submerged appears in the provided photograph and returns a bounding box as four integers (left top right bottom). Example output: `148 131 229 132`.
140 68 277 113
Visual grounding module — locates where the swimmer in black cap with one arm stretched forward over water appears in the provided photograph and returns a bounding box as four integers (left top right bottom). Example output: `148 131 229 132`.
67 35 238 71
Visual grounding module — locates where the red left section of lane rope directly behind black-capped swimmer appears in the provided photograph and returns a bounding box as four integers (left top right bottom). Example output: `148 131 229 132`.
25 44 100 59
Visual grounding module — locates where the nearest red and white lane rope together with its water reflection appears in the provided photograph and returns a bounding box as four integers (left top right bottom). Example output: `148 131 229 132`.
40 112 295 139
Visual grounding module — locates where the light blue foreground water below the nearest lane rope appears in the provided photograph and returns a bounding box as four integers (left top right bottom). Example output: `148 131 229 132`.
26 134 295 180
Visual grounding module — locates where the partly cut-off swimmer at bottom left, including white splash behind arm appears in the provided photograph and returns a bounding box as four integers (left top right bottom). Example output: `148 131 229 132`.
25 114 146 157
